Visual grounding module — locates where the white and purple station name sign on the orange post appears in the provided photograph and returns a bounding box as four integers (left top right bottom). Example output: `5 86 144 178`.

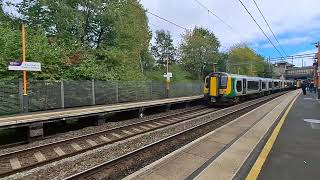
8 62 41 71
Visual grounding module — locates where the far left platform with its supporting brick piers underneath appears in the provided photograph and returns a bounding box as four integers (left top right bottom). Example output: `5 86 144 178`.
0 95 203 141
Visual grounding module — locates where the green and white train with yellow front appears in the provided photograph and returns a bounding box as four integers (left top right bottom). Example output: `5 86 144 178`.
204 72 294 104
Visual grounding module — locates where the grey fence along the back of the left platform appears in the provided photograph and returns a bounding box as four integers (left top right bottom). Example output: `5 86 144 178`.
0 80 203 116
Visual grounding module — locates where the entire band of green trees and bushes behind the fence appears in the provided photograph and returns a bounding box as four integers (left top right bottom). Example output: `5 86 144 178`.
0 0 270 81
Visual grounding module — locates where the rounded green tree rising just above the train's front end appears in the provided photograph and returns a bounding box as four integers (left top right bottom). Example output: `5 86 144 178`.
180 27 223 79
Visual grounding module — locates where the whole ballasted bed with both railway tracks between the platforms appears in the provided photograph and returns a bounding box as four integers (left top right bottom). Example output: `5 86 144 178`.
0 92 285 179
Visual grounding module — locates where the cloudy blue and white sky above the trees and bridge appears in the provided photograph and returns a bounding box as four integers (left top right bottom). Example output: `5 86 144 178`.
141 0 320 66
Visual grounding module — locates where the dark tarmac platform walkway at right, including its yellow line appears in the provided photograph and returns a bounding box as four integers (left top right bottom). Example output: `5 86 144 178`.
248 93 320 180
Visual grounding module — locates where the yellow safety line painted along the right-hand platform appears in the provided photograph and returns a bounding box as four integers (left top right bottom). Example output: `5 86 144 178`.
246 93 300 180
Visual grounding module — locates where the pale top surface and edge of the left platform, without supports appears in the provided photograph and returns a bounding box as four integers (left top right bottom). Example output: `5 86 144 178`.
0 95 203 128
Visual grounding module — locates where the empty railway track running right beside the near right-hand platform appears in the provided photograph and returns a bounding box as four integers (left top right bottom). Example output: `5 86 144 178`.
65 93 285 180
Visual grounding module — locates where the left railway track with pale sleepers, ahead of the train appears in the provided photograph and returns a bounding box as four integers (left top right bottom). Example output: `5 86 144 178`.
0 105 217 177
